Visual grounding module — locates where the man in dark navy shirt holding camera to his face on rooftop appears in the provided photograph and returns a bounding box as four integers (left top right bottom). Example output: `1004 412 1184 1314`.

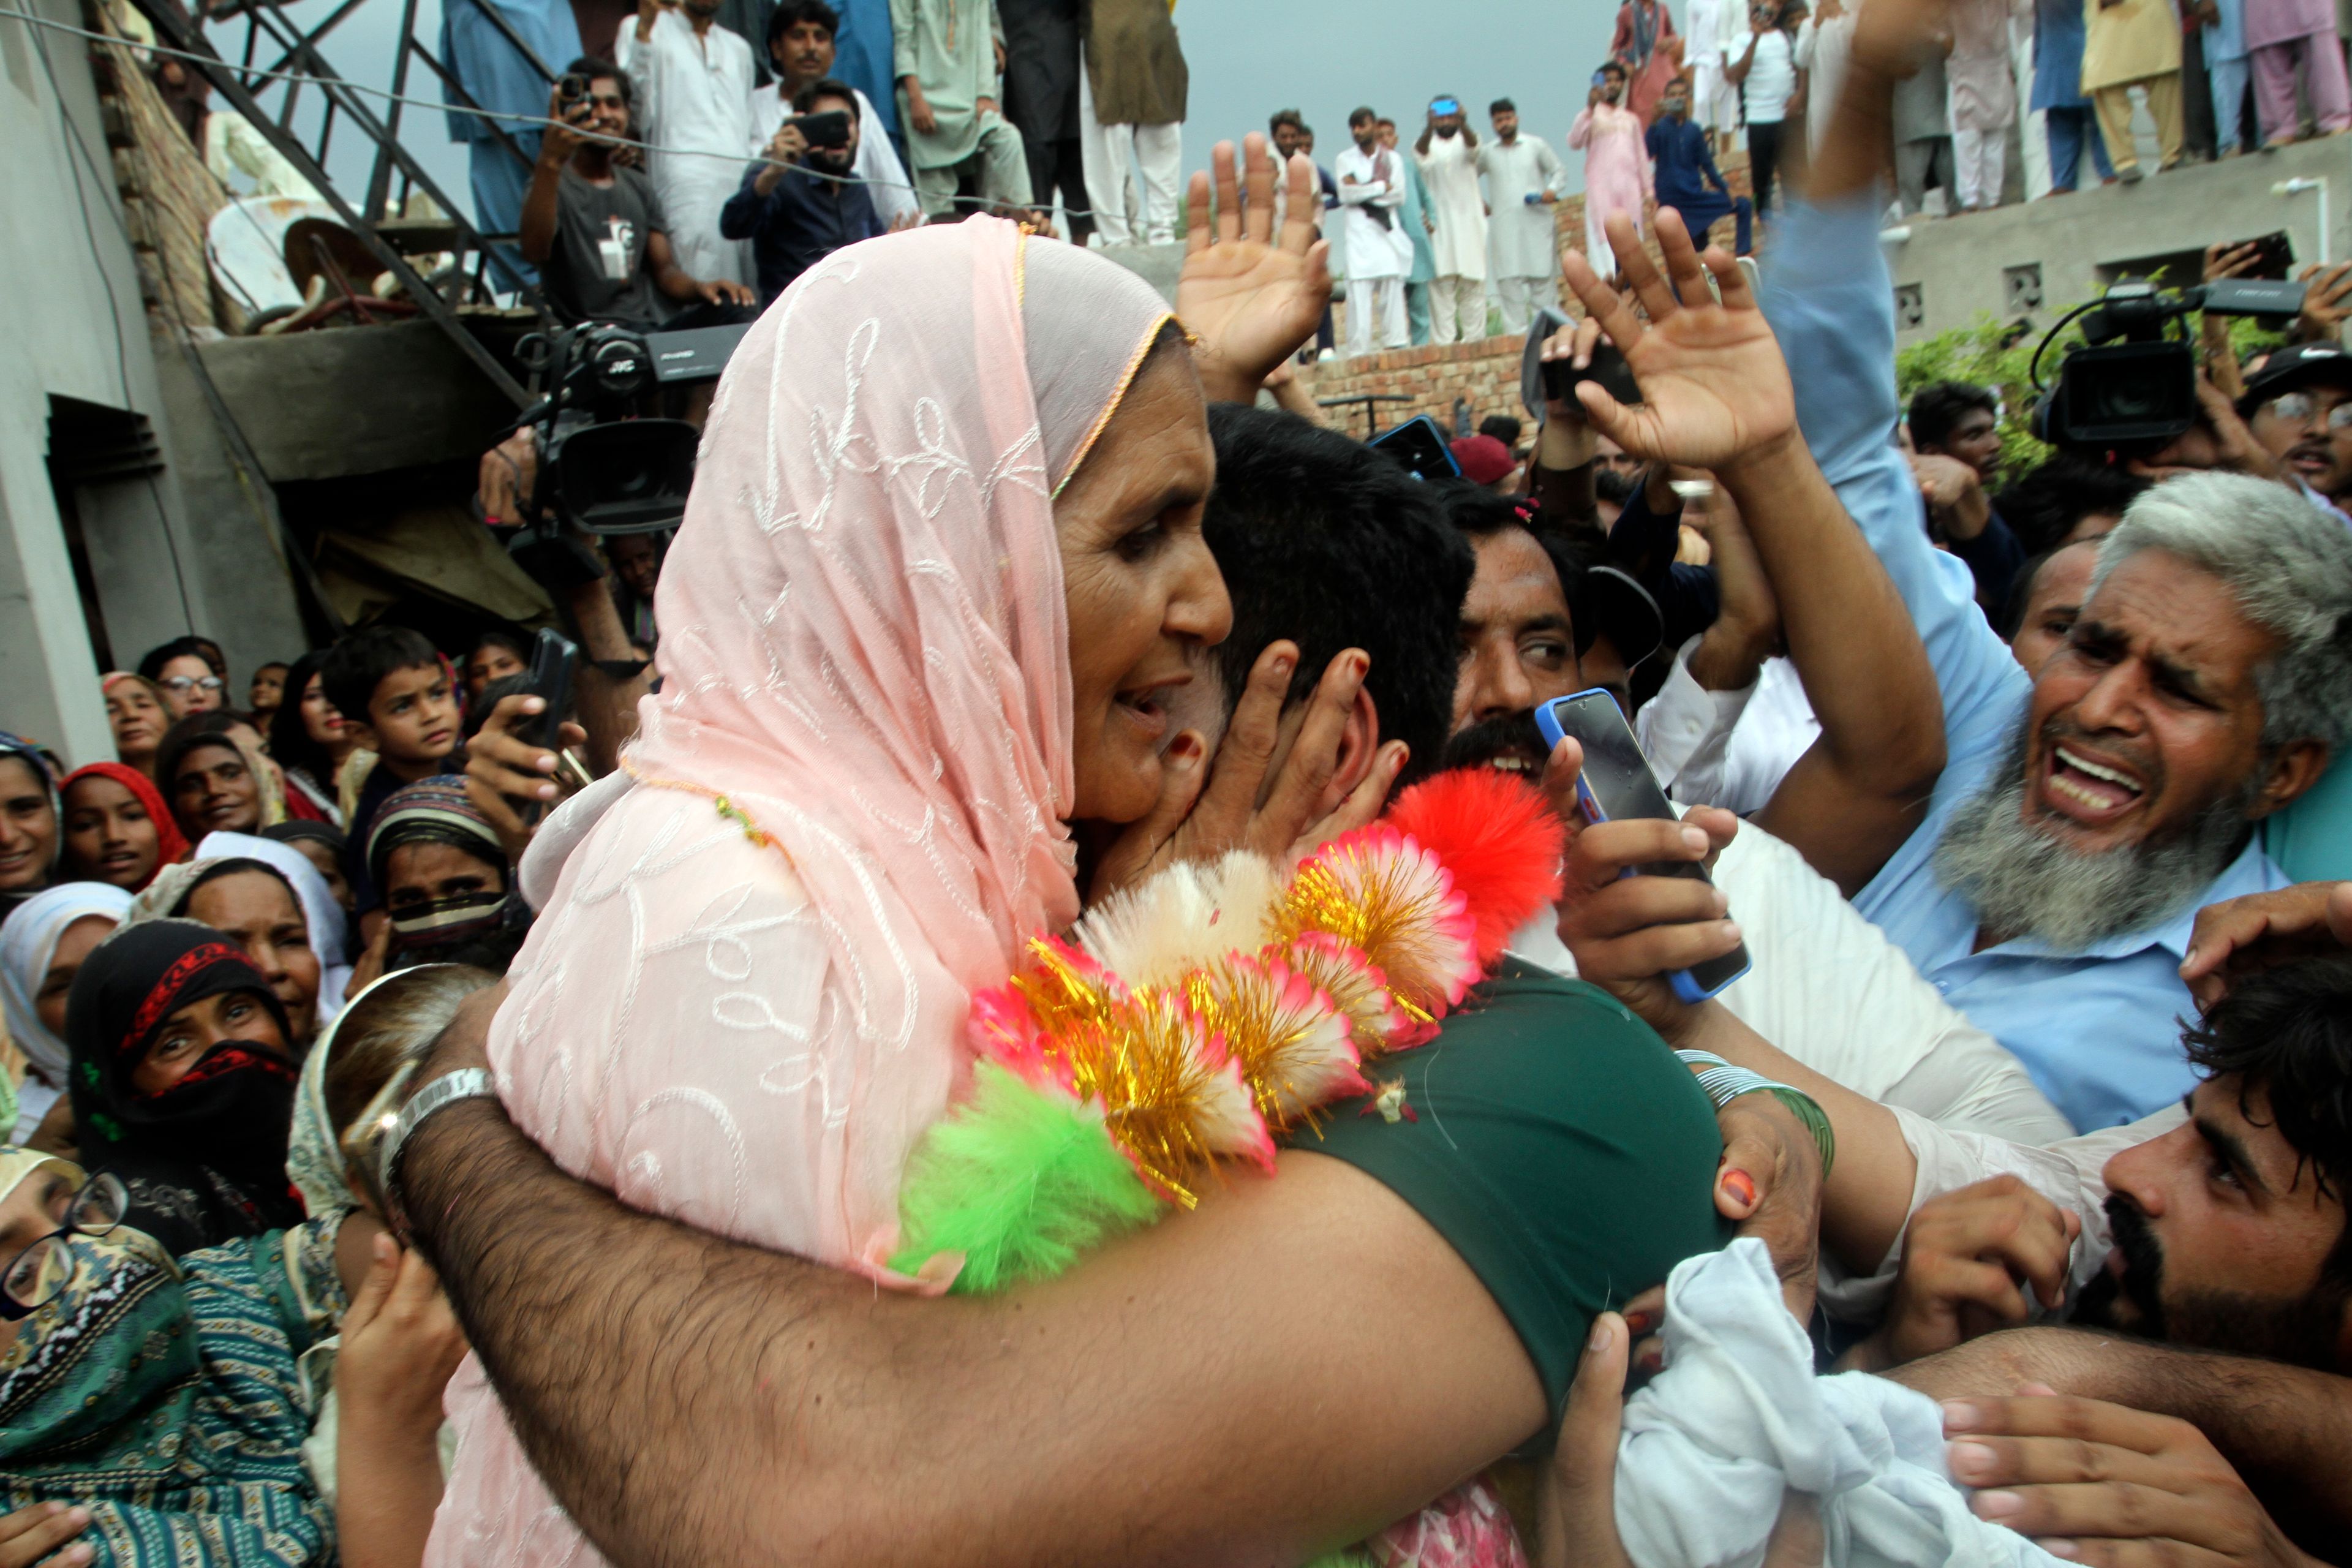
720 78 882 308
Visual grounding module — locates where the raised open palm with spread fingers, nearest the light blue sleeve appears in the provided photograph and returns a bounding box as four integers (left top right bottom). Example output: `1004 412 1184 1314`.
1562 207 1797 468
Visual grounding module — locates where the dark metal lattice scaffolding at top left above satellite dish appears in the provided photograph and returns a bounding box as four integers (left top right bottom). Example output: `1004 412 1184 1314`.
132 0 555 407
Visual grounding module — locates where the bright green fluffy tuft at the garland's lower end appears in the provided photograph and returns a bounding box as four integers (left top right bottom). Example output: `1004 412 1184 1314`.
891 1063 1162 1295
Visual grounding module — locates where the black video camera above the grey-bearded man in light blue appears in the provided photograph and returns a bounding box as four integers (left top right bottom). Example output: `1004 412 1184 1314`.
2030 277 2302 451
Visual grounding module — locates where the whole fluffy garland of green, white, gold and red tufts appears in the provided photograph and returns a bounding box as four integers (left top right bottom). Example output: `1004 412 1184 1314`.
891 769 1564 1293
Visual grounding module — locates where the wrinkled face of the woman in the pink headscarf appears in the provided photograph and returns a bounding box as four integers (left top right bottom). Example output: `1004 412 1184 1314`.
1054 348 1232 823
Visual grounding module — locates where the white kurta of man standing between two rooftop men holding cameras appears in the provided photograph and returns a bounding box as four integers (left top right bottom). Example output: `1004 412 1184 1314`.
614 9 753 284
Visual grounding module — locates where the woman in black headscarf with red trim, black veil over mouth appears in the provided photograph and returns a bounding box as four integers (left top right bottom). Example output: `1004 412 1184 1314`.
66 919 303 1256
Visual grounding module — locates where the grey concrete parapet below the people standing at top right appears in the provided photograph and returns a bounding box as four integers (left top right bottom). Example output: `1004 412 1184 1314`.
1887 137 2352 343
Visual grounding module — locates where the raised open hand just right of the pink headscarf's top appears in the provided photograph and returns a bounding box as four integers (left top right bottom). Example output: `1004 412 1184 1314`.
1176 132 1331 402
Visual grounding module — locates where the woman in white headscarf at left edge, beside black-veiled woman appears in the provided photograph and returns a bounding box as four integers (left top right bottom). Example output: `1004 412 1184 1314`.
0 881 132 1154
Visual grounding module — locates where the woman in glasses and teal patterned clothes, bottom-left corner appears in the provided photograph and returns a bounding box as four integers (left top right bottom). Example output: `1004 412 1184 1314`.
0 1145 456 1568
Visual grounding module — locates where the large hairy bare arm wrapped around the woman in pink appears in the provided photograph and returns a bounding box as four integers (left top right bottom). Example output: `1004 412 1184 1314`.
402 1030 1545 1568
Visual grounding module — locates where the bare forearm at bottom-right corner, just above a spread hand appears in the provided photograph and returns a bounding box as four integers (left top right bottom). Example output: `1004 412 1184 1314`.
1889 1329 2352 1561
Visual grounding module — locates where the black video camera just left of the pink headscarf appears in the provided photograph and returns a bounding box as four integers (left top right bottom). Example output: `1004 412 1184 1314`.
506 322 748 588
